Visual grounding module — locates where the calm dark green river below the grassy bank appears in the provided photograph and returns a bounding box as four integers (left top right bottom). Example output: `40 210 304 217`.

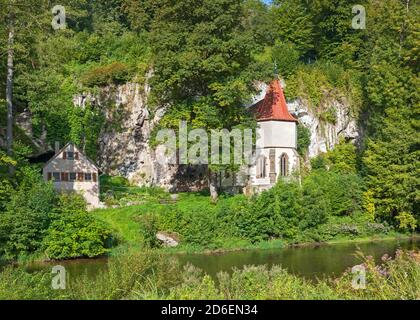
30 238 420 279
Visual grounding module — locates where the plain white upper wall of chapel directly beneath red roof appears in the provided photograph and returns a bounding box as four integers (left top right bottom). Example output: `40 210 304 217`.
257 121 297 148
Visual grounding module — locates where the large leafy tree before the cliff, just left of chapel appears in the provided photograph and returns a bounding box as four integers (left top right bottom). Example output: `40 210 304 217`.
151 0 261 200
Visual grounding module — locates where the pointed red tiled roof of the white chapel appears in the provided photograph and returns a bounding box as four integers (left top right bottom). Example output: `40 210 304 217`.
251 80 297 122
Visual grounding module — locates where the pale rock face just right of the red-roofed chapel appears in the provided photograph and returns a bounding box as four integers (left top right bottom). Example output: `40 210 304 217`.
288 100 359 158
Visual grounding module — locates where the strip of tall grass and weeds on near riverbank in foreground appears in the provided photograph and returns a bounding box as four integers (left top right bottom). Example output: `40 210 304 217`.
0 251 420 300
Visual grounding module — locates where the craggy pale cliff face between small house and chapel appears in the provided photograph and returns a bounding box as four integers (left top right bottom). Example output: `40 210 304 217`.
74 79 206 191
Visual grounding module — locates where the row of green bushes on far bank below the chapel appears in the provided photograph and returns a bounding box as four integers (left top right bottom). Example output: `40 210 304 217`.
150 172 368 248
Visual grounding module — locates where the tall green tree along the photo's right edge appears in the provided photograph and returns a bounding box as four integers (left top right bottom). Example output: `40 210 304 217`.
363 0 420 230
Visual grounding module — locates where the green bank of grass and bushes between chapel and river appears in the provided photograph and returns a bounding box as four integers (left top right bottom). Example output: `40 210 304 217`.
94 165 392 251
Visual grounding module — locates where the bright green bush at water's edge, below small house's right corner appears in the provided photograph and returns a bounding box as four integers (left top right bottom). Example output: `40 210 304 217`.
43 195 111 259
